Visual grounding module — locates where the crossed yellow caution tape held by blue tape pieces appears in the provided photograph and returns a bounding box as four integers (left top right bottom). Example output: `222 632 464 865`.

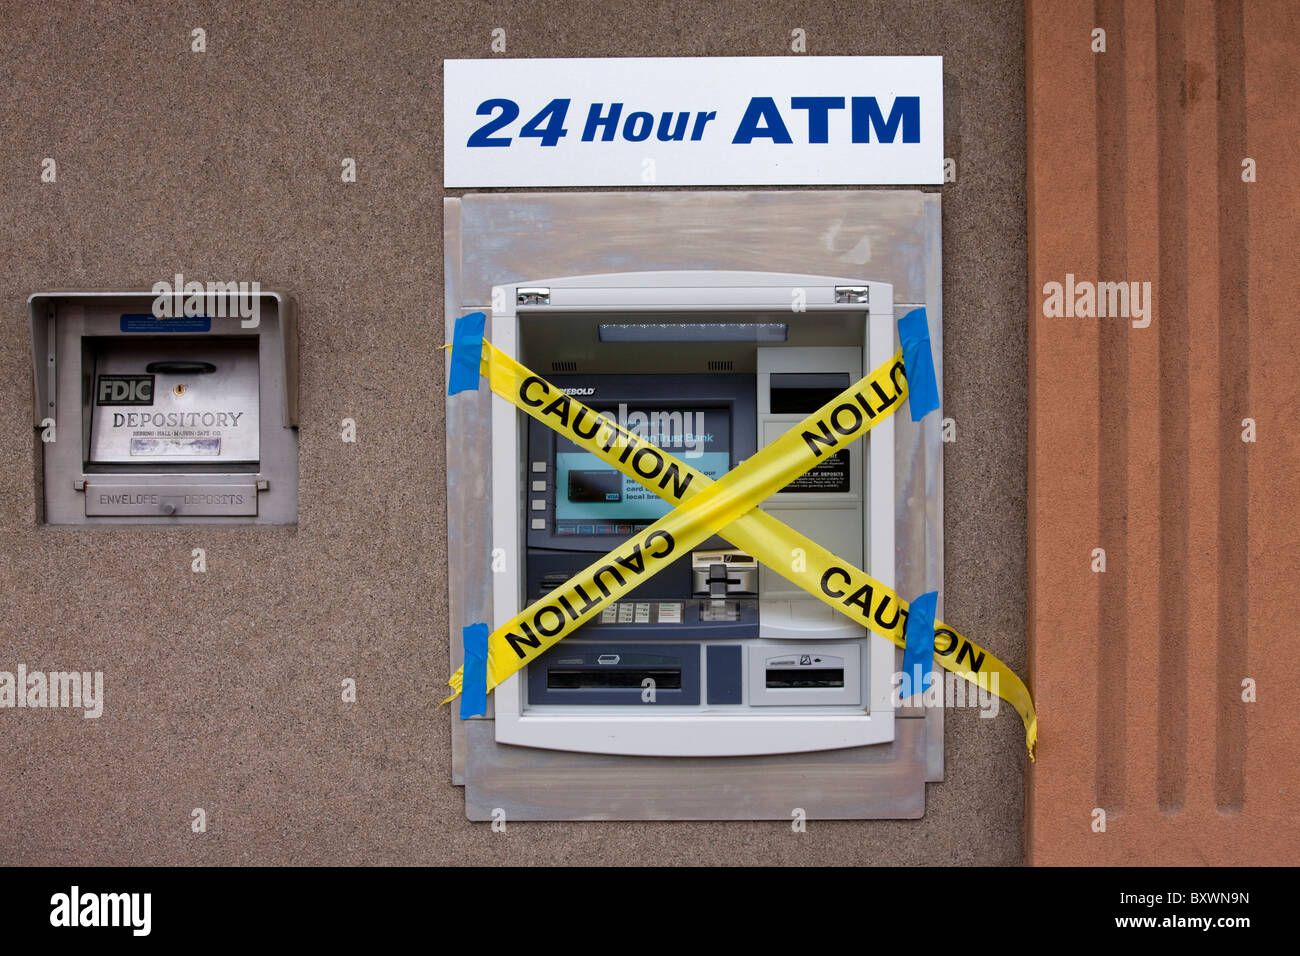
443 310 1037 760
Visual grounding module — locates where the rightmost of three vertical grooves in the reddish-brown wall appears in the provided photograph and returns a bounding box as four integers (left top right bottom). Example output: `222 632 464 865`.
1214 0 1251 813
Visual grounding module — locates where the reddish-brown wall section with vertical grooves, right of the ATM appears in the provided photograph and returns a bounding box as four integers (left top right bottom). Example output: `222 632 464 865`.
1027 0 1300 864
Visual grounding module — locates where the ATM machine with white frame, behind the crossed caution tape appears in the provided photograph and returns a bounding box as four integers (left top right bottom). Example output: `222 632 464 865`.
467 271 919 818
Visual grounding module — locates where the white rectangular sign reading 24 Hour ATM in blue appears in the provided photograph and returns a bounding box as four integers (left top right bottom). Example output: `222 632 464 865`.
443 56 944 187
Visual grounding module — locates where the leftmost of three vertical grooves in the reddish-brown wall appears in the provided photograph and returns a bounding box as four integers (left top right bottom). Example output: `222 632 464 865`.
1097 0 1130 813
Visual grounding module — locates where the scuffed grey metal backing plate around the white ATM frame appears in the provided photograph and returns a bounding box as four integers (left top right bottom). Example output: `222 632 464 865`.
442 190 944 821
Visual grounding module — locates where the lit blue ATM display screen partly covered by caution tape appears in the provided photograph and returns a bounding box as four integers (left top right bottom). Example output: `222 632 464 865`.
555 405 732 536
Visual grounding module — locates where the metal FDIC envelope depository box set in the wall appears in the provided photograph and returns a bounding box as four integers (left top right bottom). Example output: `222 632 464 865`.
29 290 298 524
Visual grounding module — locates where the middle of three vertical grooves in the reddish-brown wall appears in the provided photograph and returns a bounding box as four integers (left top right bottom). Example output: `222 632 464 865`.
1153 0 1191 813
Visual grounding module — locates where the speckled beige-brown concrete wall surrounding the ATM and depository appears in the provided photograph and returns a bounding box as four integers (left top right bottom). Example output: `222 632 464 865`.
0 0 1026 865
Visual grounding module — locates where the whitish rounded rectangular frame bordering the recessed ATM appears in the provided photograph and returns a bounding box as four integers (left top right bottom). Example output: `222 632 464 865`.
489 271 896 757
